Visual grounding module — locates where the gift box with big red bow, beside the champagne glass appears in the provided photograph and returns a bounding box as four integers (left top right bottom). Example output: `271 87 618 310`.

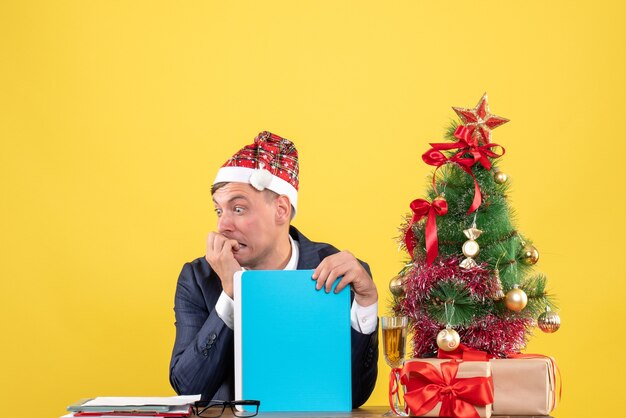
400 359 493 418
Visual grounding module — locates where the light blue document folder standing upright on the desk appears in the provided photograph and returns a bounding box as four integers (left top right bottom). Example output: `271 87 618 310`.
234 270 352 412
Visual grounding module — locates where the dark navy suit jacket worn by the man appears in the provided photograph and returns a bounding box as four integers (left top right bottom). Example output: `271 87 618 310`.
170 227 378 408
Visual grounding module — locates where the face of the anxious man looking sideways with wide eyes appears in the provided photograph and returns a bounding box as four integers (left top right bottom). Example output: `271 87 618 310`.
213 183 281 269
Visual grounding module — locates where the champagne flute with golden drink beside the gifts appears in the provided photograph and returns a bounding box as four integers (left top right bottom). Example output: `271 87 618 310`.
381 316 409 416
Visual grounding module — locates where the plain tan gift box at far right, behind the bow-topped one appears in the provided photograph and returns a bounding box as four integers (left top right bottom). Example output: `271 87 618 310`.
489 356 556 415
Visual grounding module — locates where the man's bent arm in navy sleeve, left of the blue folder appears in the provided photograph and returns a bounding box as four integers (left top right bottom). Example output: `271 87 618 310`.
170 263 234 397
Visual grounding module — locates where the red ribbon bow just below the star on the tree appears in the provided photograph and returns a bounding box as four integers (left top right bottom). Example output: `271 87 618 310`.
422 125 505 214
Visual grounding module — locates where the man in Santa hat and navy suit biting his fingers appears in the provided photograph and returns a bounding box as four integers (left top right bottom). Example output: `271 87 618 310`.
170 132 378 408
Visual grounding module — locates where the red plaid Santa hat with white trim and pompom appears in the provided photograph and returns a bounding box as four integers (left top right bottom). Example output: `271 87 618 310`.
213 131 298 215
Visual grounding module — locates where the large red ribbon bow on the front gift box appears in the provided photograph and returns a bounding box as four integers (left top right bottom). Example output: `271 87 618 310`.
400 360 493 418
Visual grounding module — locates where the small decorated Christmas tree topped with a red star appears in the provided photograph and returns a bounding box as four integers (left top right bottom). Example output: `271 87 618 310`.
390 94 560 357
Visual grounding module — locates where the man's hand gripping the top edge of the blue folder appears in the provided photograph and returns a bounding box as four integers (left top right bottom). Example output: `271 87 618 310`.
313 251 378 307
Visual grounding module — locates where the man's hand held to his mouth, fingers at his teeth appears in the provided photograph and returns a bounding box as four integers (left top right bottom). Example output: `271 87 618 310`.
205 232 241 299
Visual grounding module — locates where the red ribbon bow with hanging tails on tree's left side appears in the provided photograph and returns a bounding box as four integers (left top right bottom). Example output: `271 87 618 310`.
404 197 448 265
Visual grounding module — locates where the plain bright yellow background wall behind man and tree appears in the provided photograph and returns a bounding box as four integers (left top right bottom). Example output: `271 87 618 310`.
0 0 626 418
